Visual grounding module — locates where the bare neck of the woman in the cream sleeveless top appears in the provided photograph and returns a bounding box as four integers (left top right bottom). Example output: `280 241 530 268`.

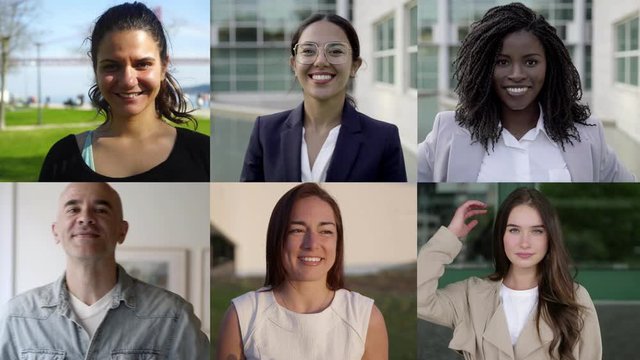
274 281 334 314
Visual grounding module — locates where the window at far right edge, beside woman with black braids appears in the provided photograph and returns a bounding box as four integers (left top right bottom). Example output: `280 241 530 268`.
614 17 640 86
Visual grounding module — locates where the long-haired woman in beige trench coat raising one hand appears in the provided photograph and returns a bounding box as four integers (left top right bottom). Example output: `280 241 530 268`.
418 188 602 360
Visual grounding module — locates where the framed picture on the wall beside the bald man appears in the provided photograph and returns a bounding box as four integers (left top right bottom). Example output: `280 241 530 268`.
116 248 189 299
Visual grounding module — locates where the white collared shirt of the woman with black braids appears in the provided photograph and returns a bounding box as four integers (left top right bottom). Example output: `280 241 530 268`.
477 108 571 182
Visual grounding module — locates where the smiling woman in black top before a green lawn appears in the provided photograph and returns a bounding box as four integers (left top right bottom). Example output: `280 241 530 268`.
40 2 209 181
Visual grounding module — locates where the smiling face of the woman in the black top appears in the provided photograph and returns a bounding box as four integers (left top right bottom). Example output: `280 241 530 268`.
95 30 166 118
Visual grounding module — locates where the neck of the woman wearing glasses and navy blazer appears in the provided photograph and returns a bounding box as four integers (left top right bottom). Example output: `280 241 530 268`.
304 96 345 130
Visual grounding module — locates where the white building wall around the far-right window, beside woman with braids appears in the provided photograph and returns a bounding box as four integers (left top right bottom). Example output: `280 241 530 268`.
592 0 640 142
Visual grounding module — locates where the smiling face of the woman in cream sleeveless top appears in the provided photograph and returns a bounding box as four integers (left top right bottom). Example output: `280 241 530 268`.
282 196 338 283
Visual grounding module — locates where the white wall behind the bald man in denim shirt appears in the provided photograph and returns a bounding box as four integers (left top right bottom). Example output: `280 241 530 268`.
15 183 210 332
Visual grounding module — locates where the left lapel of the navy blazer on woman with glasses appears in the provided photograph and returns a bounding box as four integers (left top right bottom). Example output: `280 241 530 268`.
280 103 304 181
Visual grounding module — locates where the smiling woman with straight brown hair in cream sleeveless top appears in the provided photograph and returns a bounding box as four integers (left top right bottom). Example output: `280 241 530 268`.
216 183 388 360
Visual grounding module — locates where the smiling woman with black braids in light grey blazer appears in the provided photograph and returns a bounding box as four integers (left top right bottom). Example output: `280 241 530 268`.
418 3 634 182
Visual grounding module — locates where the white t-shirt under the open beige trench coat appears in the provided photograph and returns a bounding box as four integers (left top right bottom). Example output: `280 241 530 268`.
500 284 538 345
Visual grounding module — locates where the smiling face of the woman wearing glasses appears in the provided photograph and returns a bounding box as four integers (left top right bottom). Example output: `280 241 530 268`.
290 20 362 101
